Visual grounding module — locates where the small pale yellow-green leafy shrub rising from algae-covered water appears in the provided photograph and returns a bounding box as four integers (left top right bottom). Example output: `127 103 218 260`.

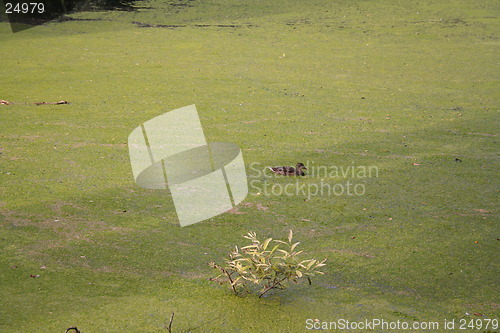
209 230 326 297
